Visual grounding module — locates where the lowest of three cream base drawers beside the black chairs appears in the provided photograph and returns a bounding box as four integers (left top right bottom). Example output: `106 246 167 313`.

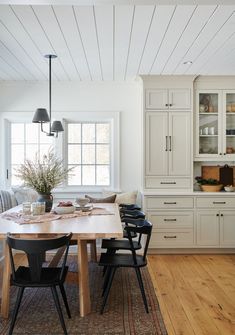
149 229 193 248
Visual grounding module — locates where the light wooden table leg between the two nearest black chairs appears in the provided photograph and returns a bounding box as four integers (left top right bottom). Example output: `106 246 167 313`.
78 239 91 317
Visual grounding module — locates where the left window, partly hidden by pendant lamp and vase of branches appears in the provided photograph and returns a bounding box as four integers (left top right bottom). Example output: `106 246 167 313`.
9 122 53 185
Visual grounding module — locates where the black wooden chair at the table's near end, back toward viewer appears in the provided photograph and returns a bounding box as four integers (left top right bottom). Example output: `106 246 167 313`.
7 233 72 335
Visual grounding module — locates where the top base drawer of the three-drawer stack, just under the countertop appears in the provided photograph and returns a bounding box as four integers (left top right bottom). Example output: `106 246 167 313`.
145 197 193 209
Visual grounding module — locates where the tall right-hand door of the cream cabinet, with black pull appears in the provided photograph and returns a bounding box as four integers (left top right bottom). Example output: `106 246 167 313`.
169 112 192 176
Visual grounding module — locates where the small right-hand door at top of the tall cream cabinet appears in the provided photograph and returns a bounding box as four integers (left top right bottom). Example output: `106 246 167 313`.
168 89 191 109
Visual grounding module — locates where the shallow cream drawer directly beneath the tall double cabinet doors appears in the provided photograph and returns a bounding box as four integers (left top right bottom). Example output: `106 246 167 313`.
145 177 190 189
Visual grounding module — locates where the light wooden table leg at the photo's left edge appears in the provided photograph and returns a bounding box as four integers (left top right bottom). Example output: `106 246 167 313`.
1 242 10 318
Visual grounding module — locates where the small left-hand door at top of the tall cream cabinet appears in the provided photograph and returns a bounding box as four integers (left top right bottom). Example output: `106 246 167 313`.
145 89 168 110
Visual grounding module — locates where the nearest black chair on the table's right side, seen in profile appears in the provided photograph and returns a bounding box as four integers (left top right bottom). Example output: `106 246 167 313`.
99 220 152 314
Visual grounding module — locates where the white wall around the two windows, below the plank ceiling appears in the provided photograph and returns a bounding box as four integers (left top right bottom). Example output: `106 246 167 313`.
0 81 142 191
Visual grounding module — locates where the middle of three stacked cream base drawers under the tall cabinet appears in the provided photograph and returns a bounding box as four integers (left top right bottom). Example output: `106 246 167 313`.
148 211 193 230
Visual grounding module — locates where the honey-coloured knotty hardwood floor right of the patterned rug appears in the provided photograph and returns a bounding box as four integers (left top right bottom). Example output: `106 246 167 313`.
148 255 235 335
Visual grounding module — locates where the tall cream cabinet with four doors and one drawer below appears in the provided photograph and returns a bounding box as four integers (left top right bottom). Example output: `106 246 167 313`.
143 76 193 190
